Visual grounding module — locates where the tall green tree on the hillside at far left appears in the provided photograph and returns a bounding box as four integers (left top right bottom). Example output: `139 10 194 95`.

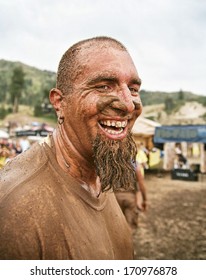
10 66 25 113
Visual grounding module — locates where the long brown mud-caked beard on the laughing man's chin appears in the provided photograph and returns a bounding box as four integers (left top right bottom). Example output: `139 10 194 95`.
93 133 137 192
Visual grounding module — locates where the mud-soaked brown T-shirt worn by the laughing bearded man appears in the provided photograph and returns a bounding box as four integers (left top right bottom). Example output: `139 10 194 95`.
0 138 133 260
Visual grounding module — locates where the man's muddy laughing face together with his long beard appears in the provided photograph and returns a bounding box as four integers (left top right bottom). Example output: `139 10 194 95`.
56 48 142 191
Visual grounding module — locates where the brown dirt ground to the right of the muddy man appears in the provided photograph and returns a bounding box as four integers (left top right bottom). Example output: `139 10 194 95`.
134 171 206 260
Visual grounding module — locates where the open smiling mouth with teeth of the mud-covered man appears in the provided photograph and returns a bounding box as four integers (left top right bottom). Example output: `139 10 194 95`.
99 120 128 135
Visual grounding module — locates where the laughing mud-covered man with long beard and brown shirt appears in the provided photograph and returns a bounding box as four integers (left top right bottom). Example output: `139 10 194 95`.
0 37 142 260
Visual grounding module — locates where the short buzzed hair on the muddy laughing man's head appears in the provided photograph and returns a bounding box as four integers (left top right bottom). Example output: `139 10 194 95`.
56 36 127 95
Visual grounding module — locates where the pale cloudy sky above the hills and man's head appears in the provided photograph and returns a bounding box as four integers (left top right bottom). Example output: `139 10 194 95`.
0 0 206 96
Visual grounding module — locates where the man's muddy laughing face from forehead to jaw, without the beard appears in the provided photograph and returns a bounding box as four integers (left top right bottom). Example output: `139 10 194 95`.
62 48 142 160
